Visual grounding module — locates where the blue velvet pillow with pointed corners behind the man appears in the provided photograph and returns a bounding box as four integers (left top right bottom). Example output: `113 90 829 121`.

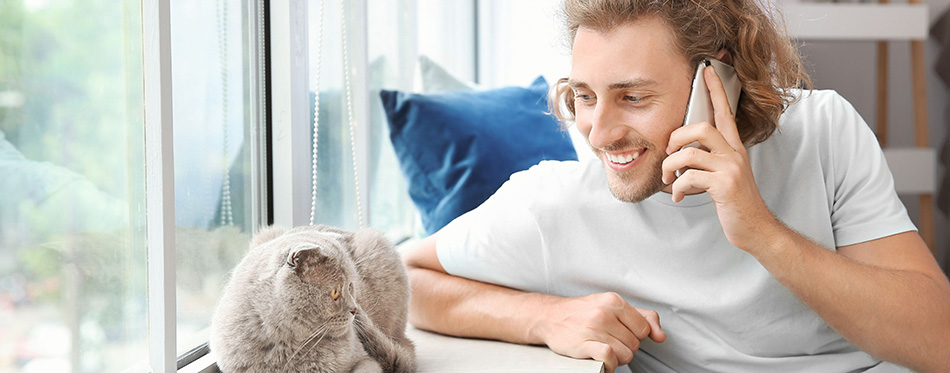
380 77 577 234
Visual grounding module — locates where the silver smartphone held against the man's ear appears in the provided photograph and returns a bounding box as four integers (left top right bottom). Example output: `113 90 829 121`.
676 58 742 177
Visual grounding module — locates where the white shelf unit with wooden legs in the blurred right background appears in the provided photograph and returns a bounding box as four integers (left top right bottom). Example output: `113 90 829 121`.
776 0 937 255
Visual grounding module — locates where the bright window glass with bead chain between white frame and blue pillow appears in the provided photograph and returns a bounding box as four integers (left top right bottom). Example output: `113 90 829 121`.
308 0 415 238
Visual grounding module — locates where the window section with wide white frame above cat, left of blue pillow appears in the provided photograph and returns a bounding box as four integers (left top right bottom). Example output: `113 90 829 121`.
269 0 415 242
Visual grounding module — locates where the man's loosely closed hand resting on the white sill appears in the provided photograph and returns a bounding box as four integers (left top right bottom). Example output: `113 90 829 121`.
531 293 666 373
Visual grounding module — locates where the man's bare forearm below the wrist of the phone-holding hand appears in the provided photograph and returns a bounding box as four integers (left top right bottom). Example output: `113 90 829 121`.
750 227 950 371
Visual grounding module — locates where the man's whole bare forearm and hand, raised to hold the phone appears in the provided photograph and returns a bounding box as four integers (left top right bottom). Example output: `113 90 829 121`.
663 67 950 371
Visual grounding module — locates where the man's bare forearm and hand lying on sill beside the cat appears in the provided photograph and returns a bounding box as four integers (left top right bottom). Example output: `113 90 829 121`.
403 233 666 372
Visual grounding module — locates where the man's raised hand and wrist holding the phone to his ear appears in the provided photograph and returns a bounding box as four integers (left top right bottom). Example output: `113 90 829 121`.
663 66 781 251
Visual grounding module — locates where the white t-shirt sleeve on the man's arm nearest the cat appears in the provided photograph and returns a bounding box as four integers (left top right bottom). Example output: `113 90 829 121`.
436 170 548 292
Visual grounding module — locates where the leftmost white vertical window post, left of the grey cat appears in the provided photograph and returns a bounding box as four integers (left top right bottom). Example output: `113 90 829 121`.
142 0 177 373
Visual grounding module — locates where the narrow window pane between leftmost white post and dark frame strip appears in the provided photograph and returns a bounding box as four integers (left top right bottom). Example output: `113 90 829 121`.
171 0 258 354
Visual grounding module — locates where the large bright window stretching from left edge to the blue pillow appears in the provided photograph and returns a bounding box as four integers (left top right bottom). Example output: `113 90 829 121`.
0 0 415 372
